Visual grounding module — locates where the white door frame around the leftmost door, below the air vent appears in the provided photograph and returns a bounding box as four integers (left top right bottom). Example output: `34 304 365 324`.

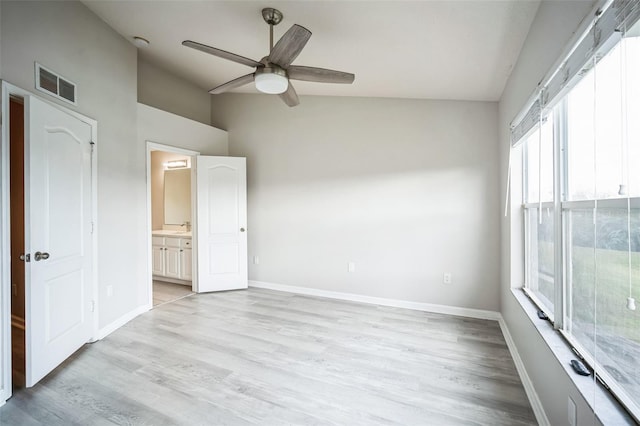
0 80 99 406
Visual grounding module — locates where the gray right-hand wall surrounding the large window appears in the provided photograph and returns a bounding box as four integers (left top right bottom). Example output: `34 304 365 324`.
499 1 608 425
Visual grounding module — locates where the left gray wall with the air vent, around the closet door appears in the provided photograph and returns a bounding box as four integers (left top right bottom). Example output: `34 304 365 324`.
0 1 147 327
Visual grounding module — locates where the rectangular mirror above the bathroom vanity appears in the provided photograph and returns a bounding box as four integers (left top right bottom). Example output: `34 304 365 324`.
164 169 191 225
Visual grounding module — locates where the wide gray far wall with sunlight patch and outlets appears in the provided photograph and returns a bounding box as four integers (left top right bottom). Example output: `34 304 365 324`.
212 94 499 310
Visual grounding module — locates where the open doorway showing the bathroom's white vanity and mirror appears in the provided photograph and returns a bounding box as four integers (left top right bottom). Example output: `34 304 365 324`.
148 143 197 307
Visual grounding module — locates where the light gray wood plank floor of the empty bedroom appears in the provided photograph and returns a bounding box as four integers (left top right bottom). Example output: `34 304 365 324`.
0 289 535 426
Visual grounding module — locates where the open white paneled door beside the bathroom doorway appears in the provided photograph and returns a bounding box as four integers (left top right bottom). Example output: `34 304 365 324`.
195 155 248 293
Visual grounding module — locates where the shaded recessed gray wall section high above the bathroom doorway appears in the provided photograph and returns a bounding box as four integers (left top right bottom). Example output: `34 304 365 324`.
138 53 211 124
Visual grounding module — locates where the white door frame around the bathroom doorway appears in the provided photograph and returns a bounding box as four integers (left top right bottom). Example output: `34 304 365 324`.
145 140 200 309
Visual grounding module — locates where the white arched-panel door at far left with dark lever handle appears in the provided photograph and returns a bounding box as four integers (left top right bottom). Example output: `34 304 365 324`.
25 96 93 387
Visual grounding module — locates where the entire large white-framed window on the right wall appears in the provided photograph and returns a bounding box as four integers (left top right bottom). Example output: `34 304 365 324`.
514 15 640 420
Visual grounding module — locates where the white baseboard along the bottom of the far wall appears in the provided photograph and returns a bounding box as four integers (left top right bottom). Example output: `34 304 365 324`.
249 280 501 321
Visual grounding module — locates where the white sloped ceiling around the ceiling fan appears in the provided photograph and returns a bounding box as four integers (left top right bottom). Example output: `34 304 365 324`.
84 0 539 101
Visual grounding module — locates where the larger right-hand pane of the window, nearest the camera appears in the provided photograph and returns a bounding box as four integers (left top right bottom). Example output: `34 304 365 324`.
562 37 640 413
